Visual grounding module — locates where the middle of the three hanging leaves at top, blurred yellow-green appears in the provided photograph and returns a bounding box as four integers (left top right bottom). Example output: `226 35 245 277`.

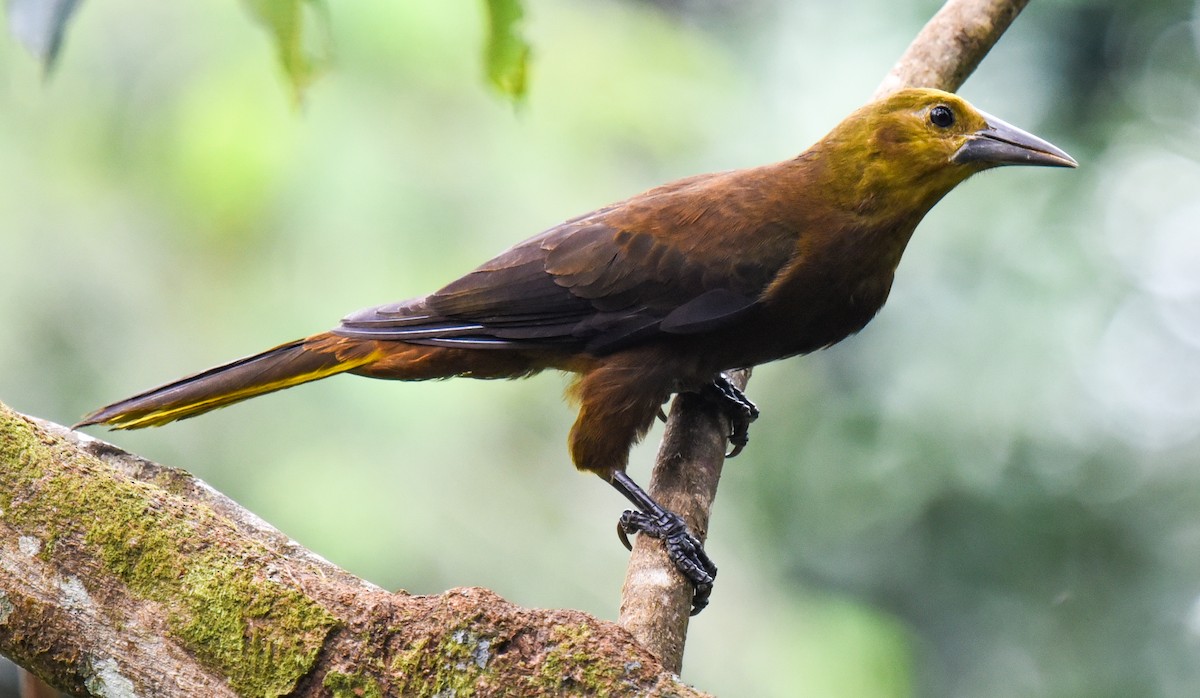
242 0 332 102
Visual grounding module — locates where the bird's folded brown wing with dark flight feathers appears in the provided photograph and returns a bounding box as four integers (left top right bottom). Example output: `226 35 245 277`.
335 165 796 354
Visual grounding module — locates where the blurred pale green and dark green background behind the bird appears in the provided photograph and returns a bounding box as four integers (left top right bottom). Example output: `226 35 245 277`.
0 0 1200 698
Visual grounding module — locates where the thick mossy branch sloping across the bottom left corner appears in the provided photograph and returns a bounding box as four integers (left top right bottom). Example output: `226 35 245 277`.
0 405 701 697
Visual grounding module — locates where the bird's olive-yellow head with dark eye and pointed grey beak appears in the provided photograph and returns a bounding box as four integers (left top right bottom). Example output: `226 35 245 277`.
822 89 1076 212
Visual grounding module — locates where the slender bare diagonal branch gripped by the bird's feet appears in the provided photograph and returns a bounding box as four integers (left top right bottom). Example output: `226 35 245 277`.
619 0 1028 672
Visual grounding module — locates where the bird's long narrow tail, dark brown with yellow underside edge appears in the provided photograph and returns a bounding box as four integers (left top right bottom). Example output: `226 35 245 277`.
76 332 382 429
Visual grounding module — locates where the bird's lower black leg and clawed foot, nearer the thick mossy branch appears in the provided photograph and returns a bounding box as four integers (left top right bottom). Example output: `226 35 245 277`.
608 470 716 615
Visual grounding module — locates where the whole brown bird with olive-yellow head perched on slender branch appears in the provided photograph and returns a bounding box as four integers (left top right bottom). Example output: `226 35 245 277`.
78 89 1075 613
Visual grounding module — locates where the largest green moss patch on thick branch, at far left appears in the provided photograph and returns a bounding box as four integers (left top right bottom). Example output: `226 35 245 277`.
0 405 337 696
